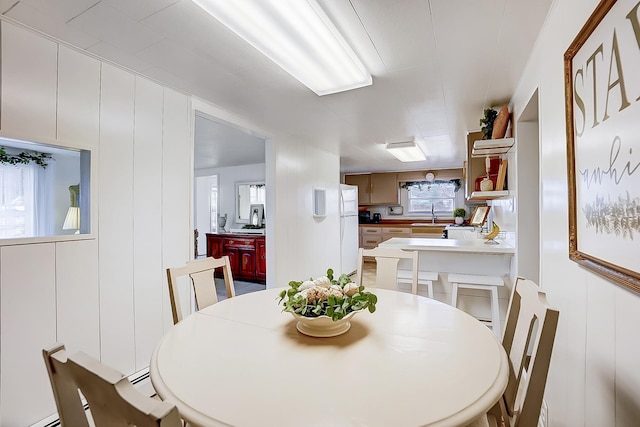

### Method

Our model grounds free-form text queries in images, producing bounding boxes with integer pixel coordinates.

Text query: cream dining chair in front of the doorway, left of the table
[167,255,236,324]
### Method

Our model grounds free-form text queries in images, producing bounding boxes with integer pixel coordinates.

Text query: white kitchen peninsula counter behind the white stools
[378,237,515,324]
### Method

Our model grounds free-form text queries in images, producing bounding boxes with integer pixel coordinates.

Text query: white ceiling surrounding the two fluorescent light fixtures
[0,0,552,172]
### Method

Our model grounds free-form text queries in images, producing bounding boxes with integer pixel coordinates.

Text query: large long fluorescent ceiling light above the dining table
[193,0,372,95]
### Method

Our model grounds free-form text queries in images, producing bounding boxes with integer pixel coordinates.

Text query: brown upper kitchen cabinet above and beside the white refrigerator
[344,173,399,205]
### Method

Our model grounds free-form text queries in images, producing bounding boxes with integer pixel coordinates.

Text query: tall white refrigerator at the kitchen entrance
[340,184,360,274]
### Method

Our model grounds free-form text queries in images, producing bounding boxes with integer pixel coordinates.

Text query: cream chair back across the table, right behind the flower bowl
[357,247,418,294]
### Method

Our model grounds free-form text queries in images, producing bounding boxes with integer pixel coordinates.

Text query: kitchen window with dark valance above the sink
[406,181,456,216]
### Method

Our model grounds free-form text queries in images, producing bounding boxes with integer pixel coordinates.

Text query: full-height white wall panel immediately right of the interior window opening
[98,64,135,375]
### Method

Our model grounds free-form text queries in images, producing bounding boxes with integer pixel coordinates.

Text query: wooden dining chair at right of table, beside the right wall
[472,277,559,427]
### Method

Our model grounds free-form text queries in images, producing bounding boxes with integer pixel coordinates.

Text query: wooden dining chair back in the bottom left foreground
[42,343,182,427]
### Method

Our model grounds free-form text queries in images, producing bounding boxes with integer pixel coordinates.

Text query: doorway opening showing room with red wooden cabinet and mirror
[193,111,266,294]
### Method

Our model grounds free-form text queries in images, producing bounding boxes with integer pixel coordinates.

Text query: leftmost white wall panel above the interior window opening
[0,22,58,139]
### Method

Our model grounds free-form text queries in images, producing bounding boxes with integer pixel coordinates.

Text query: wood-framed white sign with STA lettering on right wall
[564,0,640,292]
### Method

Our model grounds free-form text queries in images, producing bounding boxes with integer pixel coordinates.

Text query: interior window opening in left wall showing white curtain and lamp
[0,138,91,239]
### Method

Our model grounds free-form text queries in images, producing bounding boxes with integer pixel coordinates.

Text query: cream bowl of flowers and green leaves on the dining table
[279,269,378,337]
